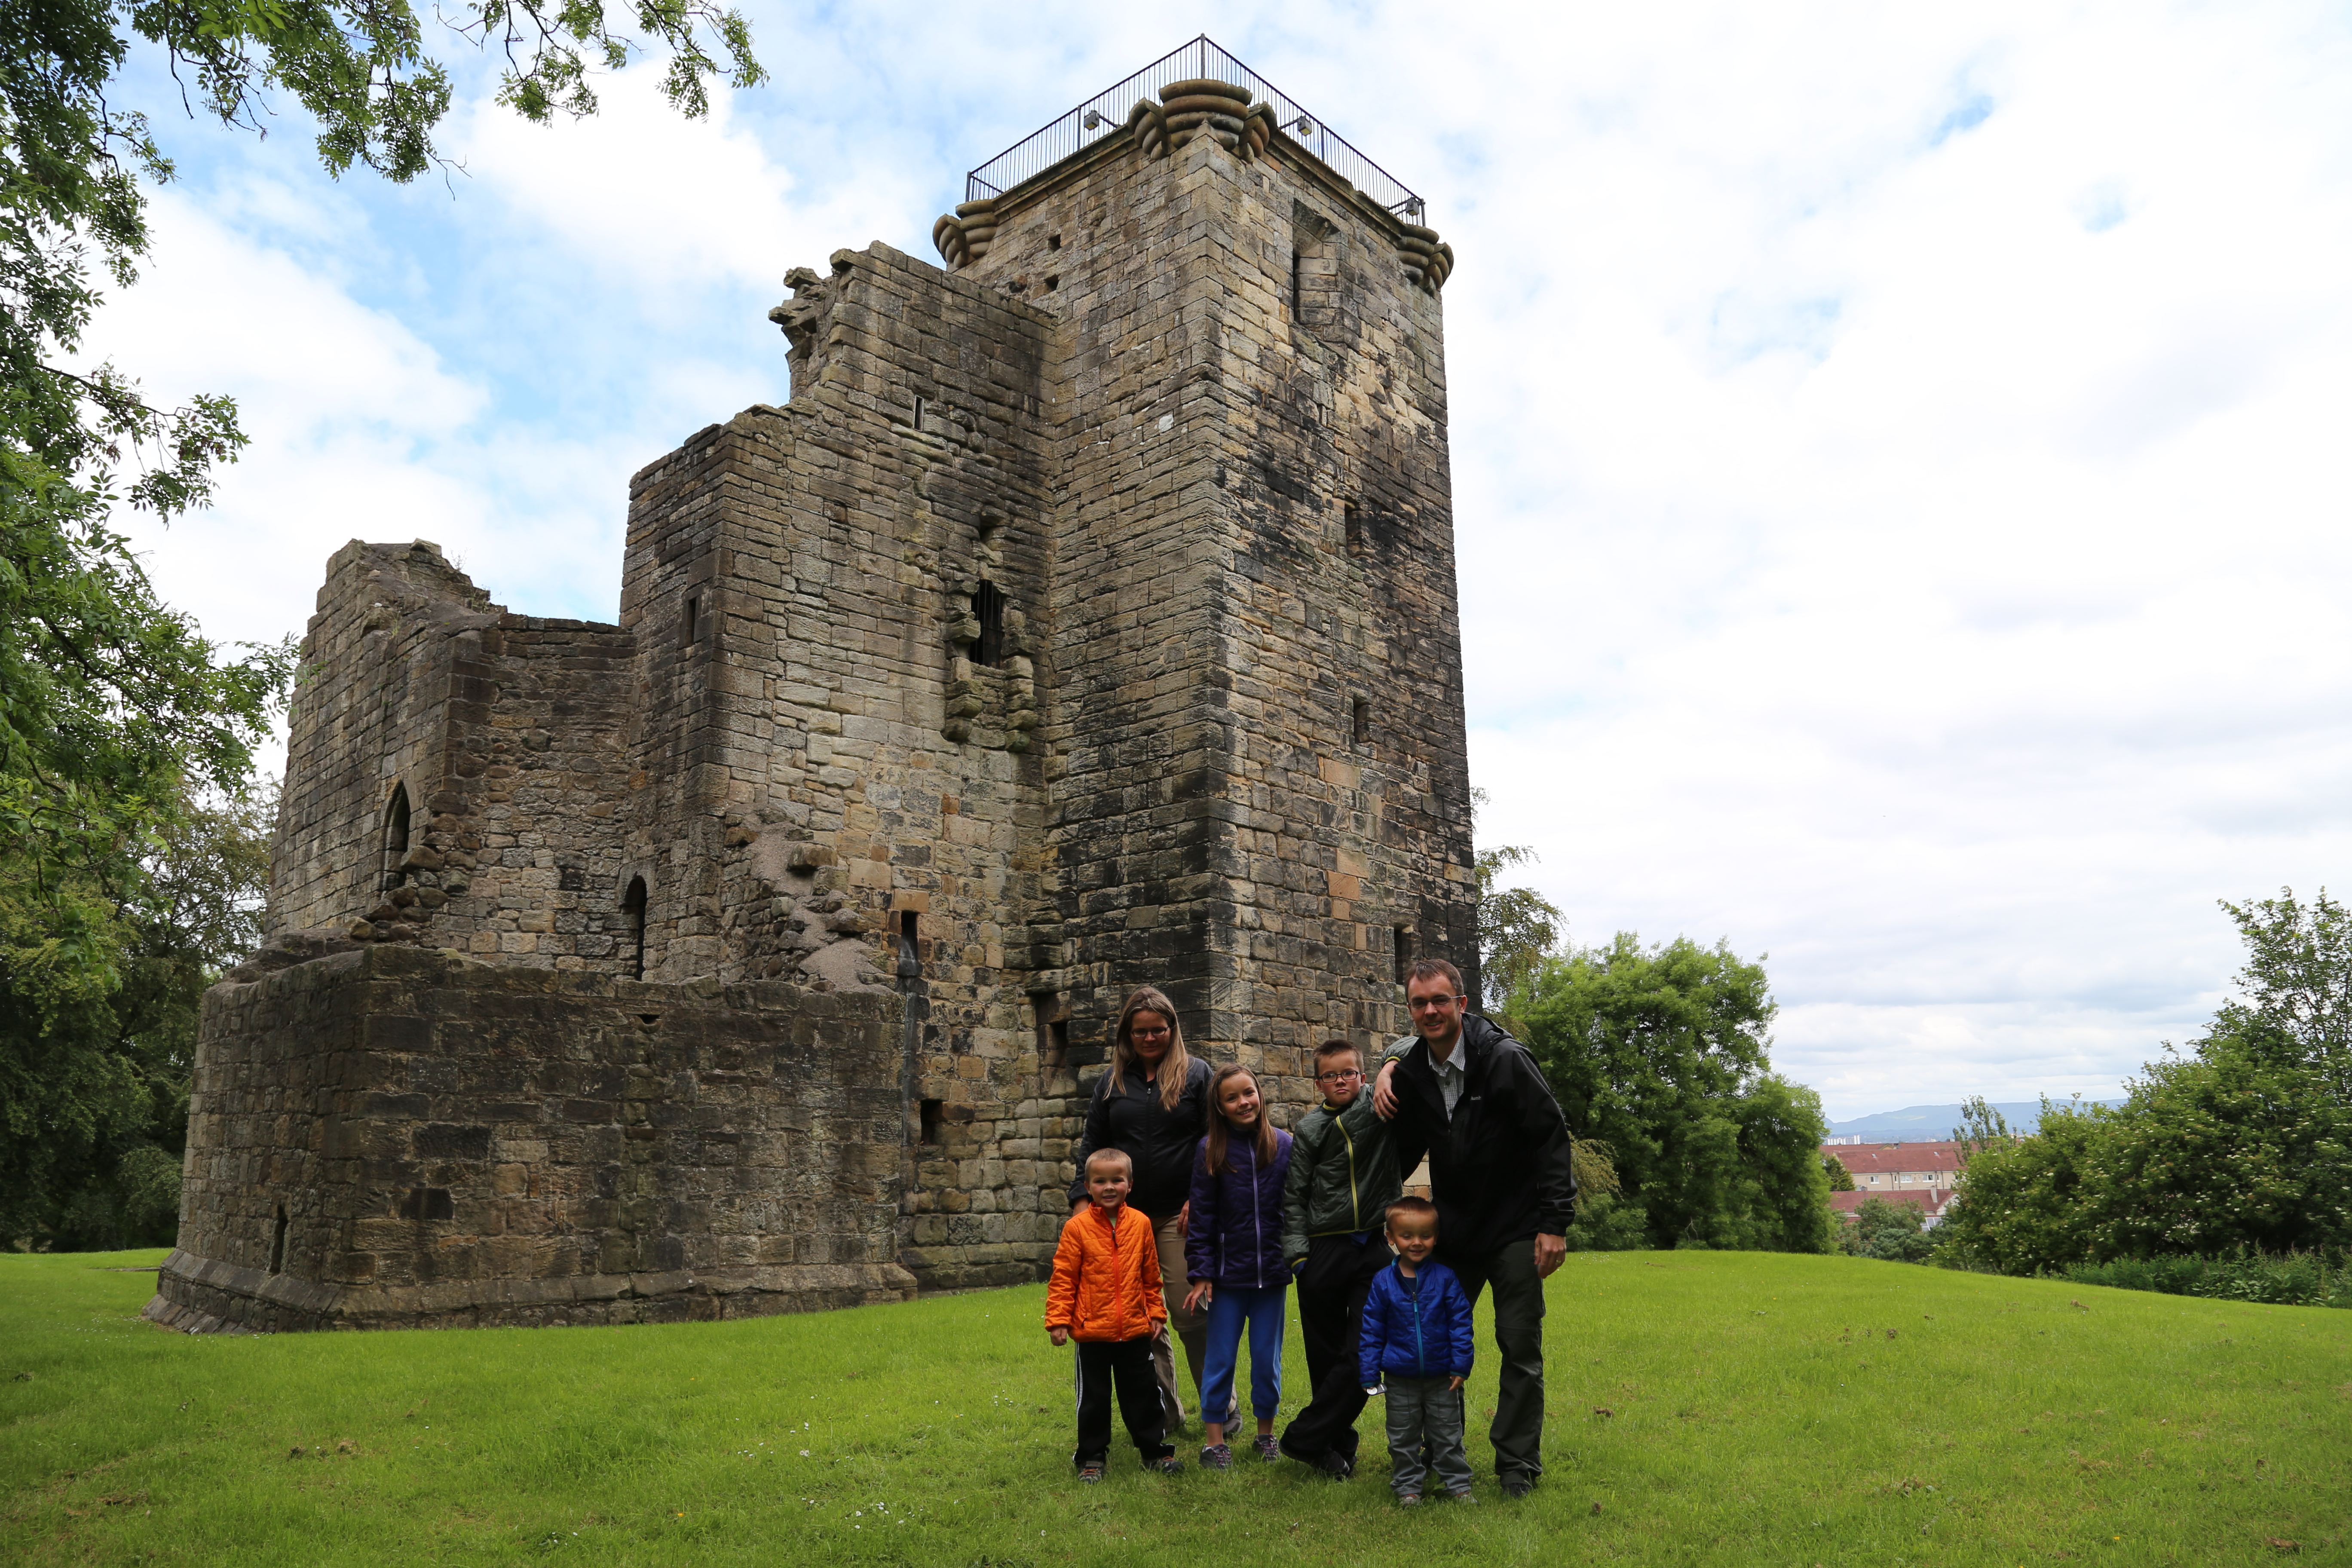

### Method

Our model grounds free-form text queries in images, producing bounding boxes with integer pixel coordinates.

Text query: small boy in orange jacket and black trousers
[1044,1149,1183,1481]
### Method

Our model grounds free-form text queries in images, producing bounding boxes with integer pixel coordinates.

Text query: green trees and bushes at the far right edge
[1938,891,2352,1274]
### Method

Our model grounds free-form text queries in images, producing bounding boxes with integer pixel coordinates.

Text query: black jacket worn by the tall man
[1390,1013,1576,1258]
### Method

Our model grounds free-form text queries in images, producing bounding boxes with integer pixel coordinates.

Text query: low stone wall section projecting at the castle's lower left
[150,945,915,1331]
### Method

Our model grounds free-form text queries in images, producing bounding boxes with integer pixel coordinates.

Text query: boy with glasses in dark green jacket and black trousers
[1282,1039,1404,1481]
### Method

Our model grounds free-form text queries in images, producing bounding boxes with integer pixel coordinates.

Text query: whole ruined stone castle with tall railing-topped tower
[150,40,1477,1328]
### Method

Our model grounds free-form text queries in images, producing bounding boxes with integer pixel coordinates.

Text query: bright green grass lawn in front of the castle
[0,1253,2352,1568]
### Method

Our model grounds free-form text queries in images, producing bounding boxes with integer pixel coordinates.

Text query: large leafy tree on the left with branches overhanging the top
[0,0,762,1239]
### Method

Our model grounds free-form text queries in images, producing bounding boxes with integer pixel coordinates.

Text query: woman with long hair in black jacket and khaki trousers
[1070,985,1209,1432]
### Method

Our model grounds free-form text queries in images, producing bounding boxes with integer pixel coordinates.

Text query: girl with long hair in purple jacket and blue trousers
[1185,1067,1291,1469]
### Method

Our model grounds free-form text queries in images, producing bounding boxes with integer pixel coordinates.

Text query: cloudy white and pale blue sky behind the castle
[99,0,2352,1117]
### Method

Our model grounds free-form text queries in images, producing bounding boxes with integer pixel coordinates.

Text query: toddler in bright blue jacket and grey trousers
[1360,1199,1472,1507]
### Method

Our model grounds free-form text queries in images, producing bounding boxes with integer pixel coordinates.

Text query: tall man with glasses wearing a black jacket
[1373,959,1576,1498]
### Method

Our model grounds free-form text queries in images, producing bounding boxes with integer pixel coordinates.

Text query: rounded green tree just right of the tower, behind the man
[1522,933,1834,1253]
